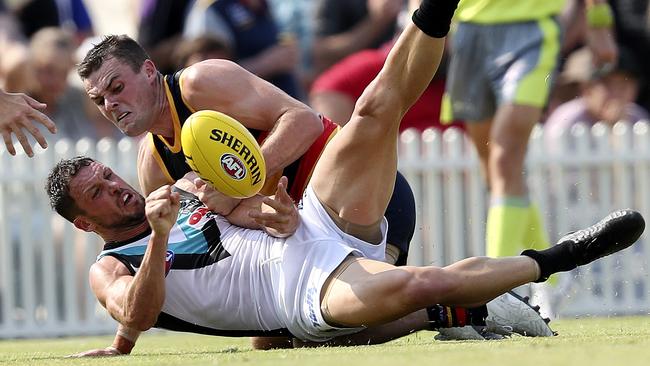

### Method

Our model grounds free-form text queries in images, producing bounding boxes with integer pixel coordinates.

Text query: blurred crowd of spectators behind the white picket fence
[0,0,650,145]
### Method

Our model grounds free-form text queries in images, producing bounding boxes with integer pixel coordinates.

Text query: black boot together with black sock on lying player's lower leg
[521,209,645,282]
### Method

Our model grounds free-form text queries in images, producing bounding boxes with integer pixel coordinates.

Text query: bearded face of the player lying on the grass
[70,161,146,230]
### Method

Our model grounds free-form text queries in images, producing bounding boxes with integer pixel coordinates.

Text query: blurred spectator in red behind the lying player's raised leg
[309,41,462,131]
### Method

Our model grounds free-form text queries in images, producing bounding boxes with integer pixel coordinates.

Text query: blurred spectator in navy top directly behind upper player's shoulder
[184,0,303,99]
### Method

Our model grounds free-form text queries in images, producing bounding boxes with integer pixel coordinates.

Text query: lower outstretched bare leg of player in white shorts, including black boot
[323,210,645,326]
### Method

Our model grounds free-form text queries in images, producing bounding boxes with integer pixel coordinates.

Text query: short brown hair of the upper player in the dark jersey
[77,34,150,79]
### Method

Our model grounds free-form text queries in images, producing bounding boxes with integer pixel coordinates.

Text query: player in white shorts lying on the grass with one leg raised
[47,0,645,355]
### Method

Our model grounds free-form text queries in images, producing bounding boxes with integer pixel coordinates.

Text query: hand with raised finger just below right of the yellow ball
[248,176,300,238]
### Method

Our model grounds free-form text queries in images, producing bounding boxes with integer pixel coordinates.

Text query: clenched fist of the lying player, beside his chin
[145,185,180,234]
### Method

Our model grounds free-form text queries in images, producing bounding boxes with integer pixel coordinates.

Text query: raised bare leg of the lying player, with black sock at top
[311,0,458,229]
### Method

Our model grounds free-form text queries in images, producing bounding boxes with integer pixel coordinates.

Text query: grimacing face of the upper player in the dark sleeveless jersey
[83,57,157,136]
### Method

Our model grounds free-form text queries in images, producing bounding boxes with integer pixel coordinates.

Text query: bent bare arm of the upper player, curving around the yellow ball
[181,60,323,176]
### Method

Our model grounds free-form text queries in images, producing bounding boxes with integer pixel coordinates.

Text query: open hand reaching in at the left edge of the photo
[0,90,56,157]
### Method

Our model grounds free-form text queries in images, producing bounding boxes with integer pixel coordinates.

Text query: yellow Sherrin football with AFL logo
[181,110,266,198]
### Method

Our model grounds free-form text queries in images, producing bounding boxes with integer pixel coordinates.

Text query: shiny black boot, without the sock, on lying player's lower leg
[557,209,645,266]
